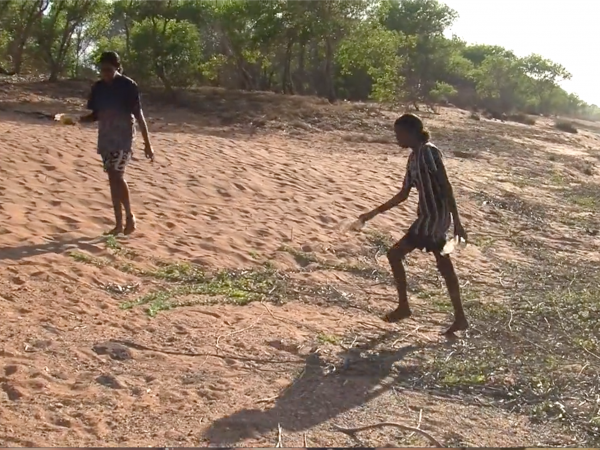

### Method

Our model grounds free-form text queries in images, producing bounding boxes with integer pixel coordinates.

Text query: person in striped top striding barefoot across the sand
[359,114,468,334]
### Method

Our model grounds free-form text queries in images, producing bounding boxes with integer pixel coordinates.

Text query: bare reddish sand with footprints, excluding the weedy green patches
[0,83,599,446]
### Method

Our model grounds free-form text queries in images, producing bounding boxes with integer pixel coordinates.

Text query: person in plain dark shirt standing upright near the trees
[80,52,154,234]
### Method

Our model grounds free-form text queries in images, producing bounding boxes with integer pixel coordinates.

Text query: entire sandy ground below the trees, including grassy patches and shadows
[0,83,600,447]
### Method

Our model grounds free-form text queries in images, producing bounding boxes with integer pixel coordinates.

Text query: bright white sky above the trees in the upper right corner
[442,0,600,105]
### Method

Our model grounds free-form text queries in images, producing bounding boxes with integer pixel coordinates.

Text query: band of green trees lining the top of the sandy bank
[0,0,600,119]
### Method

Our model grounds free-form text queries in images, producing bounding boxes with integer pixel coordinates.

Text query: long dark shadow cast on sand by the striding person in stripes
[204,333,446,446]
